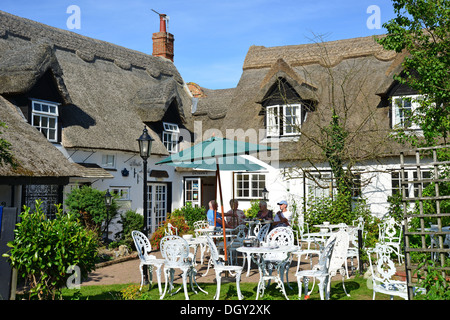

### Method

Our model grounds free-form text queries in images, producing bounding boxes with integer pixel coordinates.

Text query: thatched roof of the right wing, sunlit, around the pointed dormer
[195,37,403,161]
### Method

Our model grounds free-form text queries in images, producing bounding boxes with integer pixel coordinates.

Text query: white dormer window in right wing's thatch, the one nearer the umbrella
[266,104,302,137]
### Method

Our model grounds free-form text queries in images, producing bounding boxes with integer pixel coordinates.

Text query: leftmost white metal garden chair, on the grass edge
[131,230,164,295]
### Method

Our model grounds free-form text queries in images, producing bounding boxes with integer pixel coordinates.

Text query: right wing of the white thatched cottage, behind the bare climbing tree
[186,37,429,217]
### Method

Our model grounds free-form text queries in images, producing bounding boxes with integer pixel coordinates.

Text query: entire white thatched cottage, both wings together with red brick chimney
[0,12,428,238]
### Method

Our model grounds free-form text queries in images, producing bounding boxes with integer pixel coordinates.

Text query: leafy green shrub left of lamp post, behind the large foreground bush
[65,186,117,238]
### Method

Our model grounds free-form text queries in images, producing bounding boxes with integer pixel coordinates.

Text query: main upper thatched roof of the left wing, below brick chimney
[0,11,191,160]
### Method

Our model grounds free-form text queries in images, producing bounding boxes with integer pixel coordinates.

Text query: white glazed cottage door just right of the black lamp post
[148,183,167,234]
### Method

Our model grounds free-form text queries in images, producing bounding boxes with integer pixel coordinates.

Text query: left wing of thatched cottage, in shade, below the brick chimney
[0,12,196,235]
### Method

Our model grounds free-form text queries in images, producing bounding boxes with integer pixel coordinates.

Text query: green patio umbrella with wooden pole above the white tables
[156,137,273,260]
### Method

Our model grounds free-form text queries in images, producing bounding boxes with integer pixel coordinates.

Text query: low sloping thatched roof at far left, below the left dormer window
[0,96,84,178]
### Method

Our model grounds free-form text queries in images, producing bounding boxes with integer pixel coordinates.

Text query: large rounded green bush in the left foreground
[3,200,98,300]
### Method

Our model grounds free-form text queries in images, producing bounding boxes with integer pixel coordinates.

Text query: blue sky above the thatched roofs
[0,0,394,89]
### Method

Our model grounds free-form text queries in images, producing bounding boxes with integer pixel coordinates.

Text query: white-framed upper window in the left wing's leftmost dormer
[31,99,60,142]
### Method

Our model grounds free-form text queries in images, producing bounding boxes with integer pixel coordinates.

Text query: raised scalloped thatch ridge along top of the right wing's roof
[243,36,397,70]
